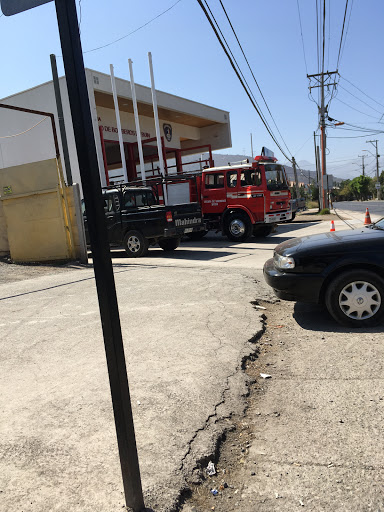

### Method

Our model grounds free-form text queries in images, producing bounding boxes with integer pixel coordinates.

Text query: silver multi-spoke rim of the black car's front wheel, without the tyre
[339,281,381,320]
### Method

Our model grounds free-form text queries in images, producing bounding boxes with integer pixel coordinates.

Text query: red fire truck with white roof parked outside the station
[158,148,292,242]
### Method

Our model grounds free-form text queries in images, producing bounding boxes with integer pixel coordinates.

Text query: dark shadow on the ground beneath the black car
[293,302,383,334]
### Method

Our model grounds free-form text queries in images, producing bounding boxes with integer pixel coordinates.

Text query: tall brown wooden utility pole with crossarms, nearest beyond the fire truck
[307,70,338,208]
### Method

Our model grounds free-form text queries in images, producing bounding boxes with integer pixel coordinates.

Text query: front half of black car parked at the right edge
[264,218,384,327]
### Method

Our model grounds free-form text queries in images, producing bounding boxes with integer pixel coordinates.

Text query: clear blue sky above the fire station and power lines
[0,0,384,179]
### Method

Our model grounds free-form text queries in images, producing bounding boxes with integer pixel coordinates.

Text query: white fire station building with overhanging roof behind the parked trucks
[0,69,231,186]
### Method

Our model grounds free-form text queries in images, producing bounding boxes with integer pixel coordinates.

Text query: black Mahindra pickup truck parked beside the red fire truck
[83,185,205,258]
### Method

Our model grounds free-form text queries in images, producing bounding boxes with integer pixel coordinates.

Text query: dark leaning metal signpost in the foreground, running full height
[55,0,144,512]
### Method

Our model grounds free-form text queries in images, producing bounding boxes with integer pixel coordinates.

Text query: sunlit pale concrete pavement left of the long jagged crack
[0,260,261,512]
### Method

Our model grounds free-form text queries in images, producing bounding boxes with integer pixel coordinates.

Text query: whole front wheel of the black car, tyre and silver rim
[325,270,384,327]
